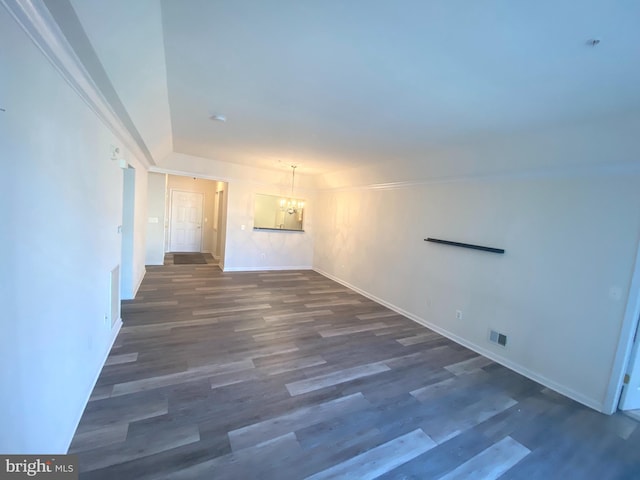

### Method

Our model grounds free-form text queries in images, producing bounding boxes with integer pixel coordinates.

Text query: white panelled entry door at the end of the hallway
[169,190,203,252]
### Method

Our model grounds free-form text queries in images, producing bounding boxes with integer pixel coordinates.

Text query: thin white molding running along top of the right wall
[317,162,640,192]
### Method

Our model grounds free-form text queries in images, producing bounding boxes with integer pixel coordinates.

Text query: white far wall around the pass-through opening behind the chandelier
[159,154,315,271]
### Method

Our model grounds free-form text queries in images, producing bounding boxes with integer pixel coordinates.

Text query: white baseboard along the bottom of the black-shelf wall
[313,268,604,412]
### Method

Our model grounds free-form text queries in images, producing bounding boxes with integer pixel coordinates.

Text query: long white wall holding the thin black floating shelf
[314,122,640,409]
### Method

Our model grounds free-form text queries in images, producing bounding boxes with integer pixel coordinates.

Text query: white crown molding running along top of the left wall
[0,0,152,168]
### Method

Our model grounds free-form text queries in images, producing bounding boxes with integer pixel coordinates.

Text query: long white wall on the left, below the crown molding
[0,8,146,454]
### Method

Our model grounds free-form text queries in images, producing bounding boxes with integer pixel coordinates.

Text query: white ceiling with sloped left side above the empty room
[62,0,640,173]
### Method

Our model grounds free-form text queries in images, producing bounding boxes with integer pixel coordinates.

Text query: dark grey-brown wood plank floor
[71,262,640,480]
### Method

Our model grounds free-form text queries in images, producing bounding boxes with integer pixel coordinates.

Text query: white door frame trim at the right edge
[603,236,640,414]
